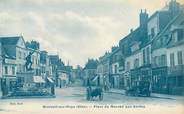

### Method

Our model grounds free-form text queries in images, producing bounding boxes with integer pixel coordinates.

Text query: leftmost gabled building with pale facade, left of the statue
[0,36,27,91]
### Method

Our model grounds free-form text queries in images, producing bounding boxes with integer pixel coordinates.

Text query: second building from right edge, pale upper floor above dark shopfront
[152,1,183,93]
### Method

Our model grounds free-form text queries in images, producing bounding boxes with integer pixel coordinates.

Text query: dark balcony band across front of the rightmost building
[168,65,184,76]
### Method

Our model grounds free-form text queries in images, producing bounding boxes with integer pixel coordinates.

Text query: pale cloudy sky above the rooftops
[0,0,184,66]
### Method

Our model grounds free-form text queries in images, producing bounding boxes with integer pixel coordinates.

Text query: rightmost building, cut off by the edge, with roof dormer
[166,12,184,95]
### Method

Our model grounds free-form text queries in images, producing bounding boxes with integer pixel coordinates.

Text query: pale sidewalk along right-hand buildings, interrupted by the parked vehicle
[106,89,184,100]
